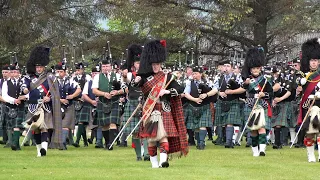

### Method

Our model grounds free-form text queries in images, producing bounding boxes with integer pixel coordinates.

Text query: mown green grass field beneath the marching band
[0,141,320,180]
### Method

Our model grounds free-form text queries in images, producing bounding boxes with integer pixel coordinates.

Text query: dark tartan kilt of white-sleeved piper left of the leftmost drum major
[3,106,25,130]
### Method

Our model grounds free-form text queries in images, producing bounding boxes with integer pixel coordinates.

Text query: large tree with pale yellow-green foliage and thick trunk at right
[101,0,319,64]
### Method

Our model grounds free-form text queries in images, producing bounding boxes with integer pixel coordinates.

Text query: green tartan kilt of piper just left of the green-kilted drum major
[214,99,243,126]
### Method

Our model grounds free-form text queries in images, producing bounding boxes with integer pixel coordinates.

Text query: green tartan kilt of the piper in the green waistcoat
[93,101,120,126]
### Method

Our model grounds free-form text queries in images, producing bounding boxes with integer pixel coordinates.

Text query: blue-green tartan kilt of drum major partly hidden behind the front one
[122,99,141,134]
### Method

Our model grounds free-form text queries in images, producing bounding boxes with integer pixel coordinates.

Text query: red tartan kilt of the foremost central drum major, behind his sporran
[139,103,179,138]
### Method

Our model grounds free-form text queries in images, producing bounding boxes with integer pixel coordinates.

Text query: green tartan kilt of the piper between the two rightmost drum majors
[271,102,290,127]
